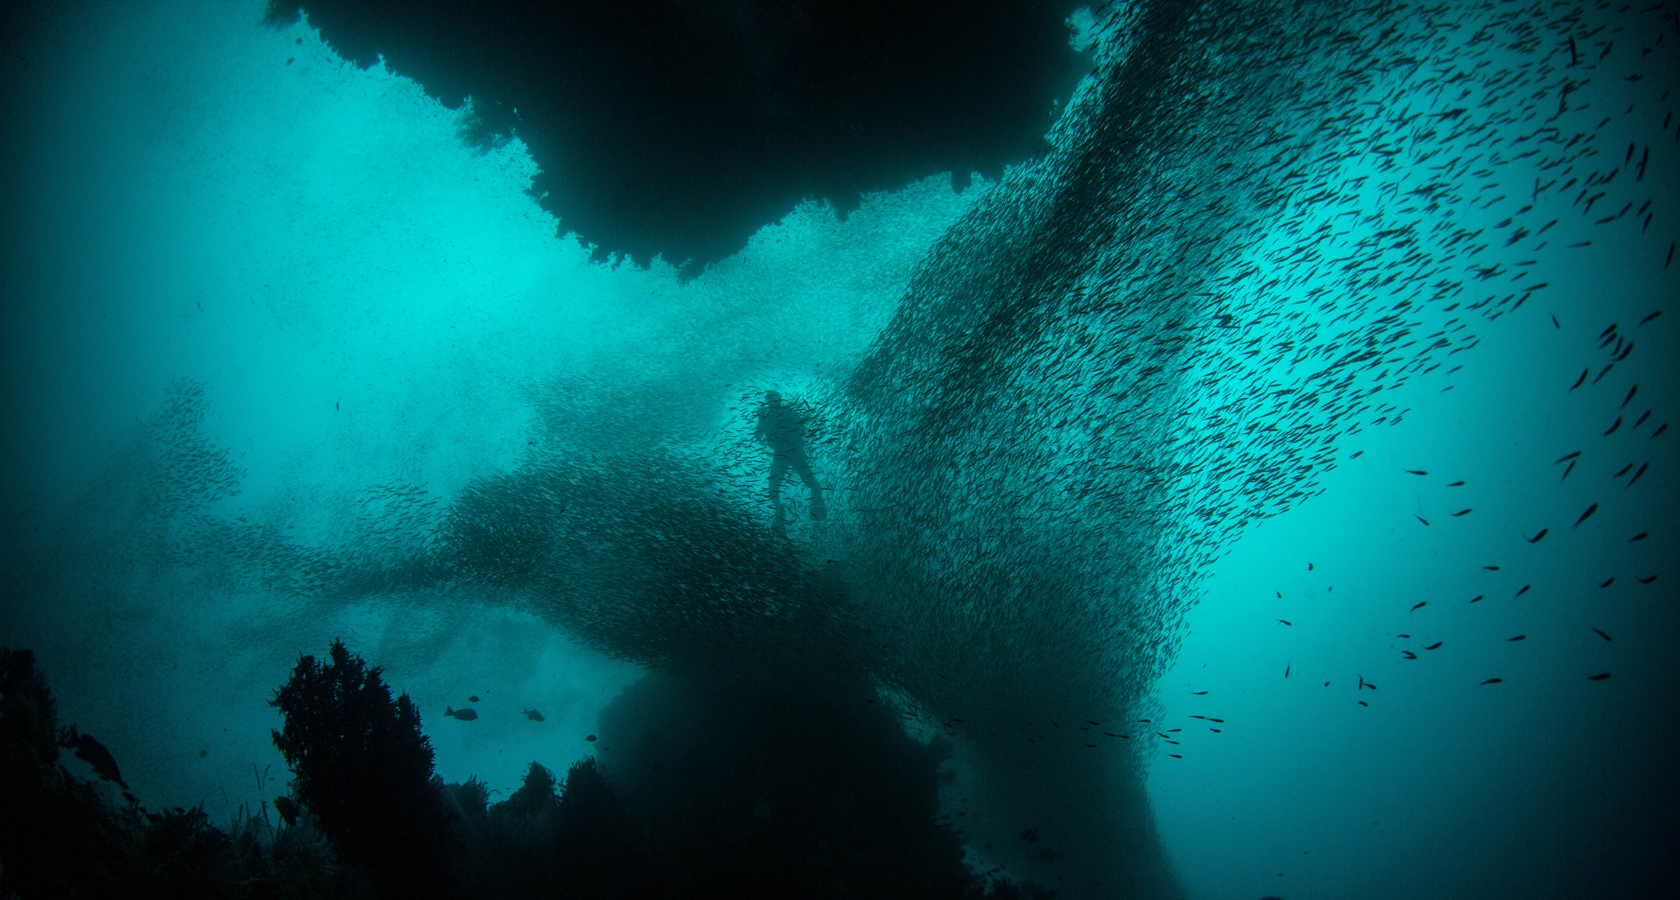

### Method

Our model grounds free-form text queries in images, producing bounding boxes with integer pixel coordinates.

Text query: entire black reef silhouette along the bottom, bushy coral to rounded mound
[0,641,1050,900]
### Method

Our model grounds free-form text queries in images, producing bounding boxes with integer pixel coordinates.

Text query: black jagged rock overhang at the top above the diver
[269,0,1089,275]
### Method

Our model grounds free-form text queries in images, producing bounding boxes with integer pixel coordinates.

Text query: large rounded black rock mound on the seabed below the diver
[591,668,971,900]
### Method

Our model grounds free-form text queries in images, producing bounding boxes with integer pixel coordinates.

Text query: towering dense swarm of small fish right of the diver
[813,2,1680,752]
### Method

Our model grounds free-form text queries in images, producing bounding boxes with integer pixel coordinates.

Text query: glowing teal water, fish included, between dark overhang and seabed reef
[0,0,1680,900]
